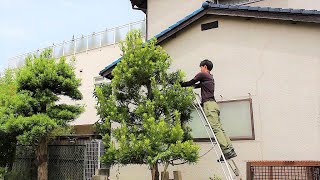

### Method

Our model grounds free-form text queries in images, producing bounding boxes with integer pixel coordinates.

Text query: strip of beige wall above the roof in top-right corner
[250,0,320,10]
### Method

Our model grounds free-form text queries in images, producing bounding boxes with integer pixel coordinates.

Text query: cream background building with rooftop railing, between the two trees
[9,20,146,125]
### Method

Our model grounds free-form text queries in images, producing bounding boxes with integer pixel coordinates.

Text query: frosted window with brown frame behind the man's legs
[190,99,255,141]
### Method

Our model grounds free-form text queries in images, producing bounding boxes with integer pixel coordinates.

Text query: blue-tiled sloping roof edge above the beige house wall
[99,1,320,78]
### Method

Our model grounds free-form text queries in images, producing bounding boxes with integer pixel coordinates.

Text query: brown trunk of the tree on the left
[36,138,48,180]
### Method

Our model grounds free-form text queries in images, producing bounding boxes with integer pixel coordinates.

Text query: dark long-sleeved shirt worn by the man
[181,72,215,103]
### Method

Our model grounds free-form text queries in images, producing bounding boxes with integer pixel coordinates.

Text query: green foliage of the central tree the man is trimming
[95,31,199,172]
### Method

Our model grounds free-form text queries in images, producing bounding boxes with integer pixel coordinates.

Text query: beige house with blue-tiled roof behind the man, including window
[100,0,320,180]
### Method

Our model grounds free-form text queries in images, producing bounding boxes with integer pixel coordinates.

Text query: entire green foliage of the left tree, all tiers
[2,50,83,146]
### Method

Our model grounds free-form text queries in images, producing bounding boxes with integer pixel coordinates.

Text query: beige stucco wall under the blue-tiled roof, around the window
[112,17,320,180]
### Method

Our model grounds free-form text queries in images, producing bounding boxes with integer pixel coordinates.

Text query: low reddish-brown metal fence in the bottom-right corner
[247,161,320,180]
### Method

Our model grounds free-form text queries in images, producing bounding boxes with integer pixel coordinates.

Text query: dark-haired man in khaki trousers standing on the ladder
[180,59,237,162]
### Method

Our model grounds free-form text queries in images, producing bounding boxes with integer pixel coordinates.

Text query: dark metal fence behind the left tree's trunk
[10,139,104,180]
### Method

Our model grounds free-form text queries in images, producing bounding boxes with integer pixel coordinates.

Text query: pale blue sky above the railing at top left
[0,0,145,70]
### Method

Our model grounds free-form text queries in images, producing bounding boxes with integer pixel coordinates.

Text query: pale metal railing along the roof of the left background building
[8,20,146,68]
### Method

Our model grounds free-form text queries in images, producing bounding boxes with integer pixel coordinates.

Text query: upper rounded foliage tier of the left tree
[17,50,82,101]
